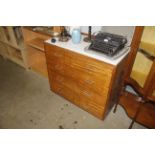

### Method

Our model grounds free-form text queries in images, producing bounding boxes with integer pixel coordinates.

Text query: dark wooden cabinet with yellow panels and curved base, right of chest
[114,26,155,128]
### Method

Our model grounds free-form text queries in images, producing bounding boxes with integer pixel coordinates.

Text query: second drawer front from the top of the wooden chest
[48,59,112,95]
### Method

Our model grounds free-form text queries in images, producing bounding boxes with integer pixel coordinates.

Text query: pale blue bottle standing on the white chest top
[72,28,81,44]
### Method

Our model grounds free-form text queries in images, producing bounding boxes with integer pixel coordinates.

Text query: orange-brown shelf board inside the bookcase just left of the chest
[27,38,44,51]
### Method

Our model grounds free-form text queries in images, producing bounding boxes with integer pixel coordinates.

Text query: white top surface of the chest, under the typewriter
[45,36,130,65]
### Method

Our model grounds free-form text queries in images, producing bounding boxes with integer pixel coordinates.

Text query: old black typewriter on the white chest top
[89,32,127,56]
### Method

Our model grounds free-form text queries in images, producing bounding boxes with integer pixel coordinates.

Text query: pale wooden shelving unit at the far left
[0,26,26,68]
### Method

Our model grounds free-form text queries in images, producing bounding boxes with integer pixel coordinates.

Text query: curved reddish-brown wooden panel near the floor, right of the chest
[119,92,155,128]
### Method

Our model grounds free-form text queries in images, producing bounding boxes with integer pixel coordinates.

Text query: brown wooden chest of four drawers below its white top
[45,43,125,119]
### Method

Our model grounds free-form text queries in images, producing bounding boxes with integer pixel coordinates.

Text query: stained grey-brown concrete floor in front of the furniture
[0,56,145,129]
